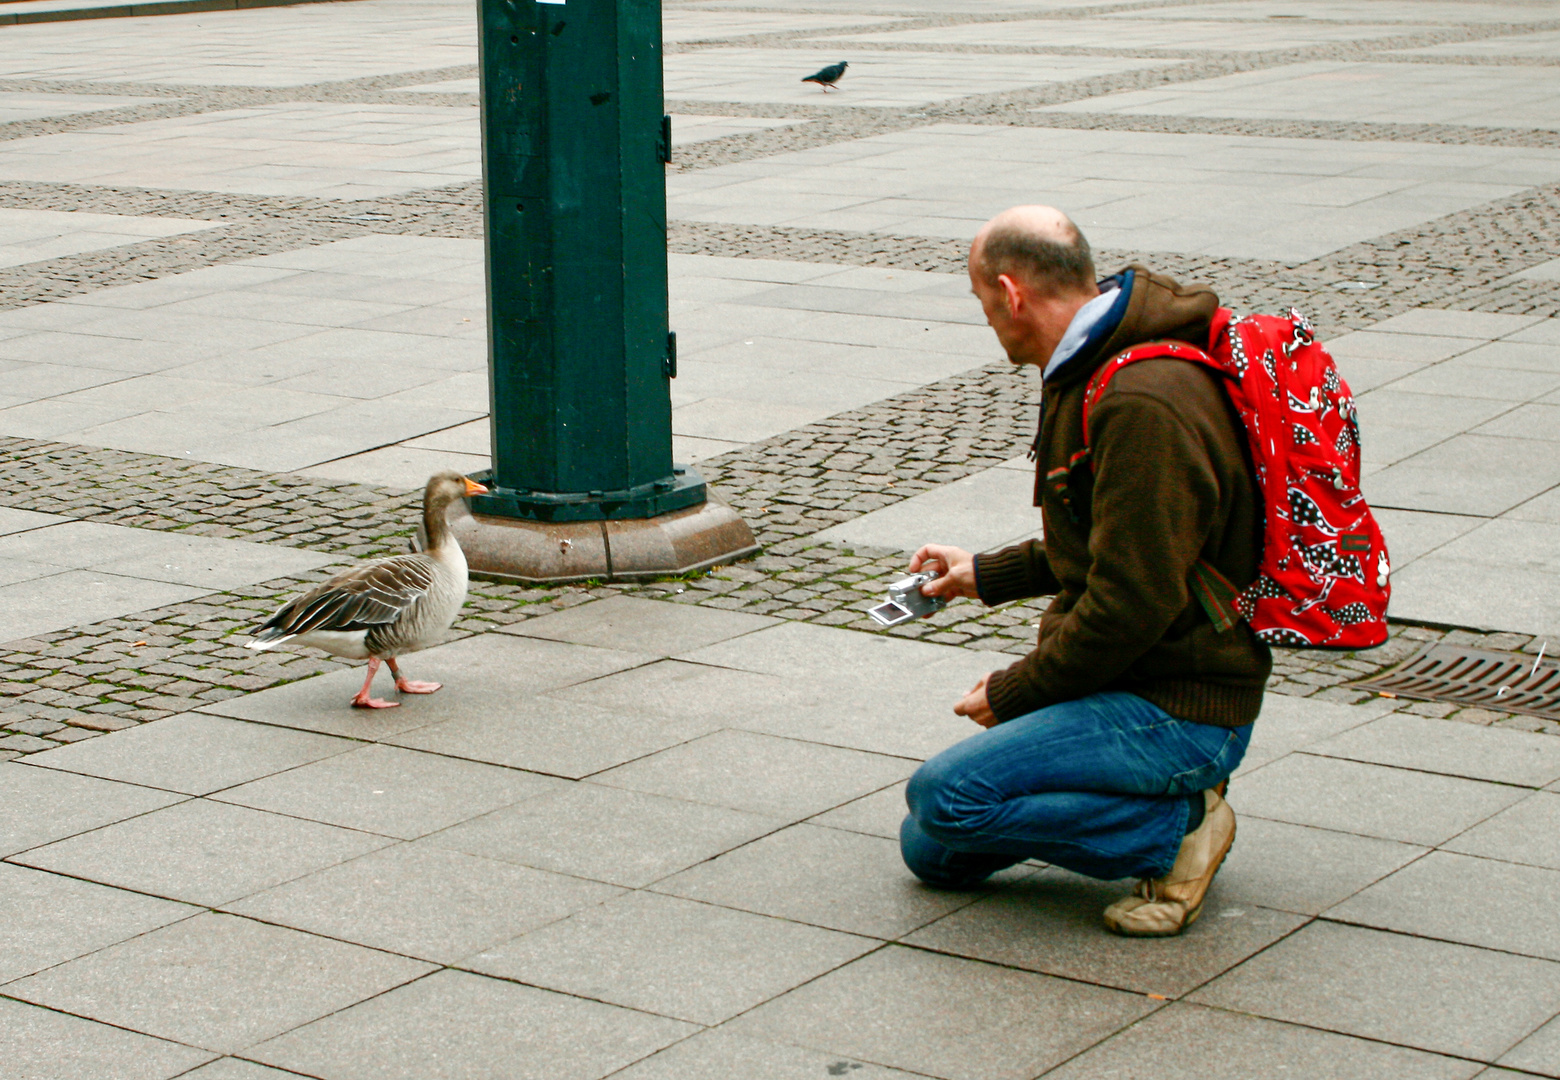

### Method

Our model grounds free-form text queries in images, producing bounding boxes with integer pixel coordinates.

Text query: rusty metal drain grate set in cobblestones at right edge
[1349,645,1560,721]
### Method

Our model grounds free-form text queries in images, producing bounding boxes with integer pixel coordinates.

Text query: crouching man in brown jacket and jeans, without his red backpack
[900,206,1273,936]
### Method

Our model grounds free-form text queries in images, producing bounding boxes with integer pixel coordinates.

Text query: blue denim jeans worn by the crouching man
[900,693,1251,888]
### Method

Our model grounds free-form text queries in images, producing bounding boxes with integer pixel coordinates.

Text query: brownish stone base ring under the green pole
[430,493,758,585]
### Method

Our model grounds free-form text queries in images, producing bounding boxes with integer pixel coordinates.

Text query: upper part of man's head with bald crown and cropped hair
[970,206,1095,295]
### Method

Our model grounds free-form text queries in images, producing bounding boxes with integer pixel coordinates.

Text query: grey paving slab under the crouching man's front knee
[654,824,1004,938]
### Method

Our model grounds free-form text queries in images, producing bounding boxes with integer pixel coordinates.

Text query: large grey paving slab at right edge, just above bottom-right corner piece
[1192,922,1560,1061]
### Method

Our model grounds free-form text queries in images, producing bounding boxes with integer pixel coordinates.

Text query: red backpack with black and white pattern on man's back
[1083,307,1392,649]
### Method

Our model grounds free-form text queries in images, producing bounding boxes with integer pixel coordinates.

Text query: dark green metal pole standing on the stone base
[471,0,705,521]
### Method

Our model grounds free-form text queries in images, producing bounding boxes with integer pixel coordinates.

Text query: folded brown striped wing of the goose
[254,554,434,641]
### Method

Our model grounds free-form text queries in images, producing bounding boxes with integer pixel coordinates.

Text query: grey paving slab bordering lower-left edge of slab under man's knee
[462,893,878,1024]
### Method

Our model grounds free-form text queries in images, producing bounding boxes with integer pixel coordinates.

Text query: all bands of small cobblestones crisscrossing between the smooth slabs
[0,3,1560,754]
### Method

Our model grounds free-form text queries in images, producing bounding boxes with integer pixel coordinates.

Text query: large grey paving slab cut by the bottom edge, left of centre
[246,971,699,1080]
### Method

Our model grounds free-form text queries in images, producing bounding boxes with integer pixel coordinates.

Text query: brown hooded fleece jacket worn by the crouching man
[975,267,1273,727]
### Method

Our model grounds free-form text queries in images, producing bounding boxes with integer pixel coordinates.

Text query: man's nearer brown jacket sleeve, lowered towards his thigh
[983,379,1220,719]
